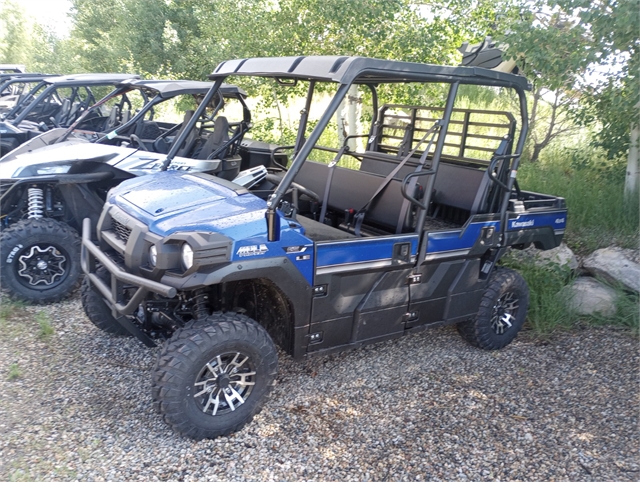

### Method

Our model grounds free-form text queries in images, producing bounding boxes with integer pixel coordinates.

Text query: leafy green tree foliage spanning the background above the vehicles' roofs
[0,0,640,165]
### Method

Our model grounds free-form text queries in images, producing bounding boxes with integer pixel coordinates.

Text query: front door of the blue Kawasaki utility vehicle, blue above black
[309,235,418,351]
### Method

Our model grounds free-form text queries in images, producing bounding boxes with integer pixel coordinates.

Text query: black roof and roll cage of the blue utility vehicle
[170,56,531,243]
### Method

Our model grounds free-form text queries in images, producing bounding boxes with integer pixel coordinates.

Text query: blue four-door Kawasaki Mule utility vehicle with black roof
[82,57,567,439]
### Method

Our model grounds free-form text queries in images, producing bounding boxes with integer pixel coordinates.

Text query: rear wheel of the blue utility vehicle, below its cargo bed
[457,268,529,350]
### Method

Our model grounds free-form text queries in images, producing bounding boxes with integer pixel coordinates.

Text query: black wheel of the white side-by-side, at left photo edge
[0,218,81,304]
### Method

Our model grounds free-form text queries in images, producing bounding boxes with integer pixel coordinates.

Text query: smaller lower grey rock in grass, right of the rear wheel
[561,276,618,318]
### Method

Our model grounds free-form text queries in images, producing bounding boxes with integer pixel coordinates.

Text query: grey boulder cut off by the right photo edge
[582,248,640,292]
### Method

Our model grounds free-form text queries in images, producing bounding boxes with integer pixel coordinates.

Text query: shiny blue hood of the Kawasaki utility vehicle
[108,171,267,239]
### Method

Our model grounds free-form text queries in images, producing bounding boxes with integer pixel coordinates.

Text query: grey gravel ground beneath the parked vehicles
[0,299,640,481]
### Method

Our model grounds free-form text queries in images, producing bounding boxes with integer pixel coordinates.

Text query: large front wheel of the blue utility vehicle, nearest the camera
[152,313,278,440]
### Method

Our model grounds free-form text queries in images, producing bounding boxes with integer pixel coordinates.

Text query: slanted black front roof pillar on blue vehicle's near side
[266,84,351,241]
